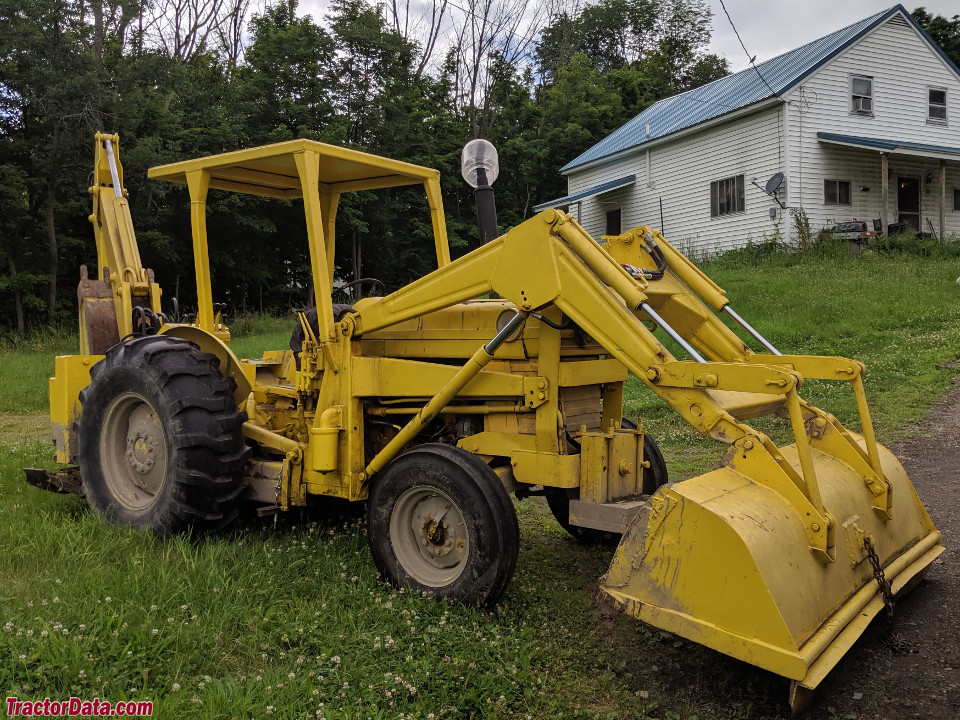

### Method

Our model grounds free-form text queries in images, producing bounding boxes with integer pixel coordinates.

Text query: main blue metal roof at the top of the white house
[560,5,960,172]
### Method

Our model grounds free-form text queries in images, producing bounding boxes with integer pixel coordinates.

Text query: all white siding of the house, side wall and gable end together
[568,6,960,250]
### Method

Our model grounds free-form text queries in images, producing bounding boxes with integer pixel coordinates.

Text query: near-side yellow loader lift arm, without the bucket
[352,210,887,562]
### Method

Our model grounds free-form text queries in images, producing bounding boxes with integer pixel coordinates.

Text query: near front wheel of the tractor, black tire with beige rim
[367,443,520,606]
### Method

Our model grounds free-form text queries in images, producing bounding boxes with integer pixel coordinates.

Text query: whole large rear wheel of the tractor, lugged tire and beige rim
[76,335,250,537]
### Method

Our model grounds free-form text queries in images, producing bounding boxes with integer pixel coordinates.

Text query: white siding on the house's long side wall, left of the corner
[568,107,785,256]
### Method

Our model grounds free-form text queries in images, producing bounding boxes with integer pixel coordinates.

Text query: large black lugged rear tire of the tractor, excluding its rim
[74,335,250,537]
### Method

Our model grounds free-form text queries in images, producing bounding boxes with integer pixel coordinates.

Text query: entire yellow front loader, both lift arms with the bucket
[351,211,943,708]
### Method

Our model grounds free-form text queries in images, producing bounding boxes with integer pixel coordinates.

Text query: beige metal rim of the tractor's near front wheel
[390,486,470,588]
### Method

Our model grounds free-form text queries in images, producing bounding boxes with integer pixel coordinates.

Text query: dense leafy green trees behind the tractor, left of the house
[0,0,726,332]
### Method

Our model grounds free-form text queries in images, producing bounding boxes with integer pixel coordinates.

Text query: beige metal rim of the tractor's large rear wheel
[100,392,167,510]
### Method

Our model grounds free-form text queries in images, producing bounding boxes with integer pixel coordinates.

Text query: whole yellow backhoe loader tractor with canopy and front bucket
[27,135,943,706]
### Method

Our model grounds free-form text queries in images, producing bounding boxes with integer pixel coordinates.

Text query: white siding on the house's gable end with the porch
[785,15,960,235]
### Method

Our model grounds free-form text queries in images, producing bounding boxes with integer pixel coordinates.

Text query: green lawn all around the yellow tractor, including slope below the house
[0,250,960,720]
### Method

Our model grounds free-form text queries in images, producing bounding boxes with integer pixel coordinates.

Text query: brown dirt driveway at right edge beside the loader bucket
[807,378,960,720]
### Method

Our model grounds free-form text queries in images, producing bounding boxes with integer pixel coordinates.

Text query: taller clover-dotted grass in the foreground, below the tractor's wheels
[0,442,724,719]
